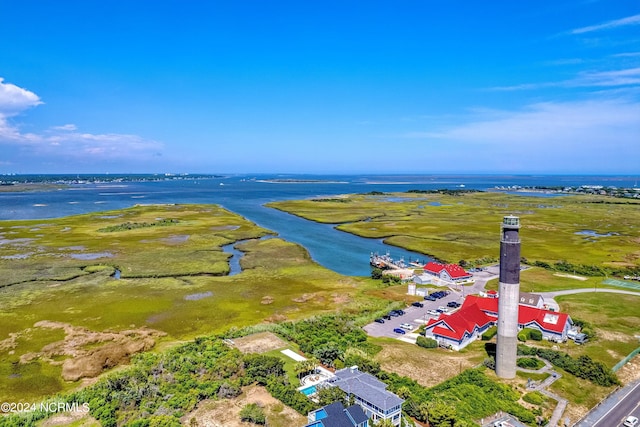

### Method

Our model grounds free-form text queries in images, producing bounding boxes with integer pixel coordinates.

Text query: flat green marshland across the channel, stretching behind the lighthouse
[269,193,640,267]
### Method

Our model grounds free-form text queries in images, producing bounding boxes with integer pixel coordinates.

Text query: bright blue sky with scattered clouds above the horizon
[0,0,640,175]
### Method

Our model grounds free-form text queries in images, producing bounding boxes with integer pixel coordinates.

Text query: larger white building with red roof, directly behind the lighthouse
[425,295,573,350]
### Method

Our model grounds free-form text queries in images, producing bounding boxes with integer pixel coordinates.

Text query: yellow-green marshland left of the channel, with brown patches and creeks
[0,205,384,400]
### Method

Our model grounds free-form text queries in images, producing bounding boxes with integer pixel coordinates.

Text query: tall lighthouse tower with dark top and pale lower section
[496,215,520,378]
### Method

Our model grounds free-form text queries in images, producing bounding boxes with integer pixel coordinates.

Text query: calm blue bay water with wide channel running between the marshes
[0,175,637,276]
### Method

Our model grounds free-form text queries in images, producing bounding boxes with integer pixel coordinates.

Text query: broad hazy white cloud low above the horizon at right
[403,100,640,173]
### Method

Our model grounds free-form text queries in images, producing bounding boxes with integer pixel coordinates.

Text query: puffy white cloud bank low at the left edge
[0,78,163,169]
